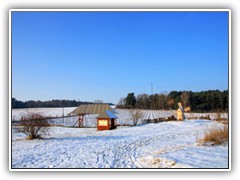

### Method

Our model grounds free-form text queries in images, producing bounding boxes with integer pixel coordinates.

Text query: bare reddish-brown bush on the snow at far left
[18,113,50,140]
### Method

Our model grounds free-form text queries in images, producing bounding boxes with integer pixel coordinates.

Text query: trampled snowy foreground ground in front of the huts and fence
[12,120,228,168]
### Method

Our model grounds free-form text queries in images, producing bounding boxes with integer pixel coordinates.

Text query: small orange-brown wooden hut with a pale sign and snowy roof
[97,110,117,130]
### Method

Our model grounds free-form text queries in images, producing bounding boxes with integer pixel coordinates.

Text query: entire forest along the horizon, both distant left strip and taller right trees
[12,90,228,112]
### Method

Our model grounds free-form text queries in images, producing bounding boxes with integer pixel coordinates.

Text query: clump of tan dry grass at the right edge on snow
[198,125,228,145]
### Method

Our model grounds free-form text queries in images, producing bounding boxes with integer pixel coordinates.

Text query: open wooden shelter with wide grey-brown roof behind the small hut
[69,104,117,127]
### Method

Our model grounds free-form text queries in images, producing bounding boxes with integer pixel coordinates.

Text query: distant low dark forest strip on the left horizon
[12,98,112,109]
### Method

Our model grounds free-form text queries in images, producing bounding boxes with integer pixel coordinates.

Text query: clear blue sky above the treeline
[11,12,228,103]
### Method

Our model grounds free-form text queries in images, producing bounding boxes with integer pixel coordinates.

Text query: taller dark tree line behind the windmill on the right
[117,90,228,112]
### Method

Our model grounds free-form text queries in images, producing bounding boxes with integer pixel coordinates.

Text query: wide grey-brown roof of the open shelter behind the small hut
[69,104,117,114]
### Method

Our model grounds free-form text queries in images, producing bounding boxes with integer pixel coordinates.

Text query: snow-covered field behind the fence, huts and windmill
[12,107,228,127]
